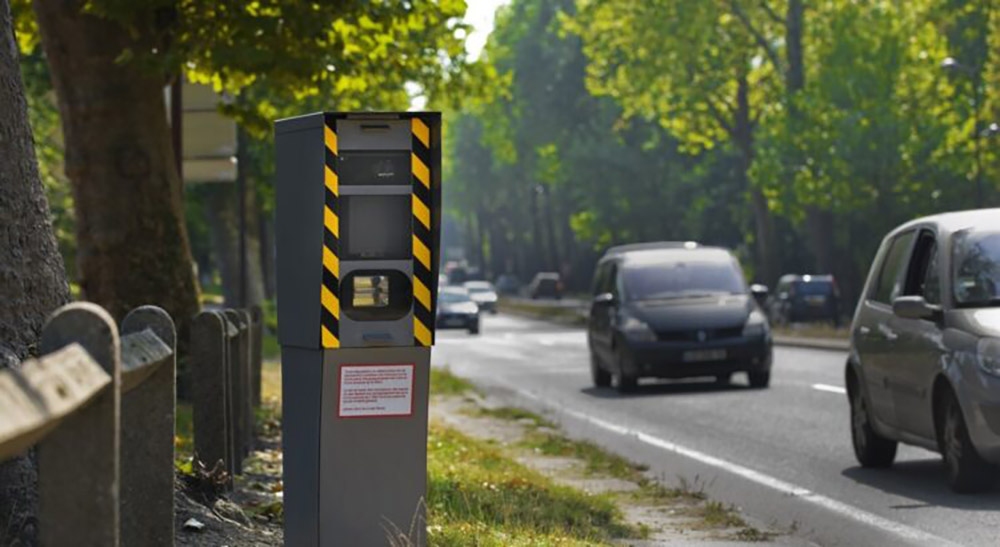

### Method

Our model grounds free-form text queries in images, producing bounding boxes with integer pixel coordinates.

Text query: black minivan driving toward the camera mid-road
[587,243,771,391]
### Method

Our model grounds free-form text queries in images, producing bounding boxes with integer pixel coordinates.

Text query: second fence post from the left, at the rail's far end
[121,306,177,547]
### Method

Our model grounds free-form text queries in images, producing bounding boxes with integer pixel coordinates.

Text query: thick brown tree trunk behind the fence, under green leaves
[34,0,199,332]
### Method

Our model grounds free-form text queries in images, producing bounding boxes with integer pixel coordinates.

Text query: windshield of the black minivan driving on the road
[623,261,746,300]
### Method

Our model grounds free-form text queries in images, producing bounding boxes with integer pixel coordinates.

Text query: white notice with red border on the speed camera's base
[339,364,414,418]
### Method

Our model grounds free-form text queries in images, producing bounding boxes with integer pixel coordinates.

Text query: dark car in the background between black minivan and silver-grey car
[767,274,840,326]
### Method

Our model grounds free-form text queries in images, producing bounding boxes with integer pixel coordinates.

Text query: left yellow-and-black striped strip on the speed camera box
[320,115,340,349]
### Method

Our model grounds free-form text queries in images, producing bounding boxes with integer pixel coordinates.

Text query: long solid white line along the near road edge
[501,380,958,546]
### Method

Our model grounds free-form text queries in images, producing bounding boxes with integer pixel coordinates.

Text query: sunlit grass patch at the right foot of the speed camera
[426,426,644,546]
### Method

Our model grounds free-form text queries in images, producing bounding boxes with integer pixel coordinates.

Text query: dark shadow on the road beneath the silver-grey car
[842,457,1000,511]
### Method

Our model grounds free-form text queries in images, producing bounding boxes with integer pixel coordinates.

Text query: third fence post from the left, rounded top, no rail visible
[190,311,234,484]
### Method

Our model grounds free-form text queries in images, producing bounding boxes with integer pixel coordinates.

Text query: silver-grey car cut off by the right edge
[846,209,1000,492]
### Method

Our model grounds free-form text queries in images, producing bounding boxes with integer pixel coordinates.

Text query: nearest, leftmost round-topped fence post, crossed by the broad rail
[38,302,121,547]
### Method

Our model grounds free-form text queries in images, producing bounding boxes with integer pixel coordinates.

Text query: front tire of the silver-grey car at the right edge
[939,393,997,494]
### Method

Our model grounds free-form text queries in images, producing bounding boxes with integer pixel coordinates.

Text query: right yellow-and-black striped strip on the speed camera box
[410,118,436,346]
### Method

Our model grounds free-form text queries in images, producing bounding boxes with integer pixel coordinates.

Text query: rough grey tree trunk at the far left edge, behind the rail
[0,0,69,545]
